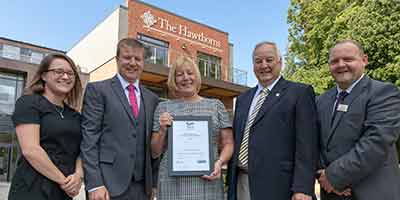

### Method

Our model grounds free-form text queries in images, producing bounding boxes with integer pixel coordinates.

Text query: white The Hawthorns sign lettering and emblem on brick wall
[141,11,221,48]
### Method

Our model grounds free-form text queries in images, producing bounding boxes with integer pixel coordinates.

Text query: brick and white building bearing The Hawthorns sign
[67,0,248,111]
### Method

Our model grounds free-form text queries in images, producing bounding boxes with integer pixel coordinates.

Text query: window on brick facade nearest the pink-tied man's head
[138,35,169,65]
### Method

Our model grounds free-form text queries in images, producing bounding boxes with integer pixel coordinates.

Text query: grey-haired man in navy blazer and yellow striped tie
[228,42,319,200]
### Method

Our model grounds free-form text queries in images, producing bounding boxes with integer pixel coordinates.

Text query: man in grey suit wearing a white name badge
[317,40,400,200]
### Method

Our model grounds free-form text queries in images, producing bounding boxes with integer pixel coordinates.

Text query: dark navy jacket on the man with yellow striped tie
[228,78,319,200]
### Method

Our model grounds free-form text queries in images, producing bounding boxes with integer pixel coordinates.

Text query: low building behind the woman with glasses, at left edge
[0,37,89,183]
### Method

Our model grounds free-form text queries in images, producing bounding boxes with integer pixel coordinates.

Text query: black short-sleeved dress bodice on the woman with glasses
[12,94,82,176]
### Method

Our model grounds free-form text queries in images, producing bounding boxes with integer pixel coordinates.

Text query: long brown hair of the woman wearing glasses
[25,53,82,108]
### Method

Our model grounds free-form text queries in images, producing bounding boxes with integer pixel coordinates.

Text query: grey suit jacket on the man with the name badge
[317,76,400,200]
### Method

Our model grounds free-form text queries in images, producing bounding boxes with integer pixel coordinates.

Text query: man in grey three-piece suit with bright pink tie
[81,38,159,200]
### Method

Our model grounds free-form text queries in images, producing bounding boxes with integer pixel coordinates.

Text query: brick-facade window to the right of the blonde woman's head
[197,52,221,79]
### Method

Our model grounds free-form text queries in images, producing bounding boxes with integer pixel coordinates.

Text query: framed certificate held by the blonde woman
[168,116,214,176]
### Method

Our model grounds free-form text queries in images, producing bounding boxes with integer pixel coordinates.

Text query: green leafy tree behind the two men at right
[285,0,400,93]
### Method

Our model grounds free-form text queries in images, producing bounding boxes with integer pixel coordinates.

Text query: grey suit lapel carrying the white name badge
[327,75,369,144]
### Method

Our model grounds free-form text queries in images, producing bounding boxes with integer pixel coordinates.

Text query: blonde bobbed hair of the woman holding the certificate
[167,56,201,97]
